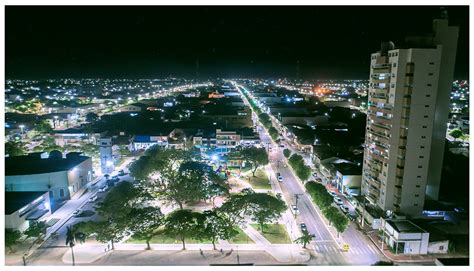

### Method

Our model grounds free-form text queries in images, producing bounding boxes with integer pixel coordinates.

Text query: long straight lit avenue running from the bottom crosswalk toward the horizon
[238,82,385,265]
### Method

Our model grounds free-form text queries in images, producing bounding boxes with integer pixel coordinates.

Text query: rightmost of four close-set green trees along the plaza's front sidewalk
[199,211,238,250]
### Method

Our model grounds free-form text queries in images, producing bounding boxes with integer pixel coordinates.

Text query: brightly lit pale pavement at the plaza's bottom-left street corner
[62,245,111,265]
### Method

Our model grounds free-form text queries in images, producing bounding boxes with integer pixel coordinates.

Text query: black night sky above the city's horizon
[5,6,469,79]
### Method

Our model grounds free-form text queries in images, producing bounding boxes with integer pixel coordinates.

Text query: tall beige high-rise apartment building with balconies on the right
[362,19,459,216]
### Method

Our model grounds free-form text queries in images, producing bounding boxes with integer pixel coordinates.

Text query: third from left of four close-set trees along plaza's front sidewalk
[165,210,204,250]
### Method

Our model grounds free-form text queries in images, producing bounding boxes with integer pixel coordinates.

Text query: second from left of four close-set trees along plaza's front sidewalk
[129,207,163,249]
